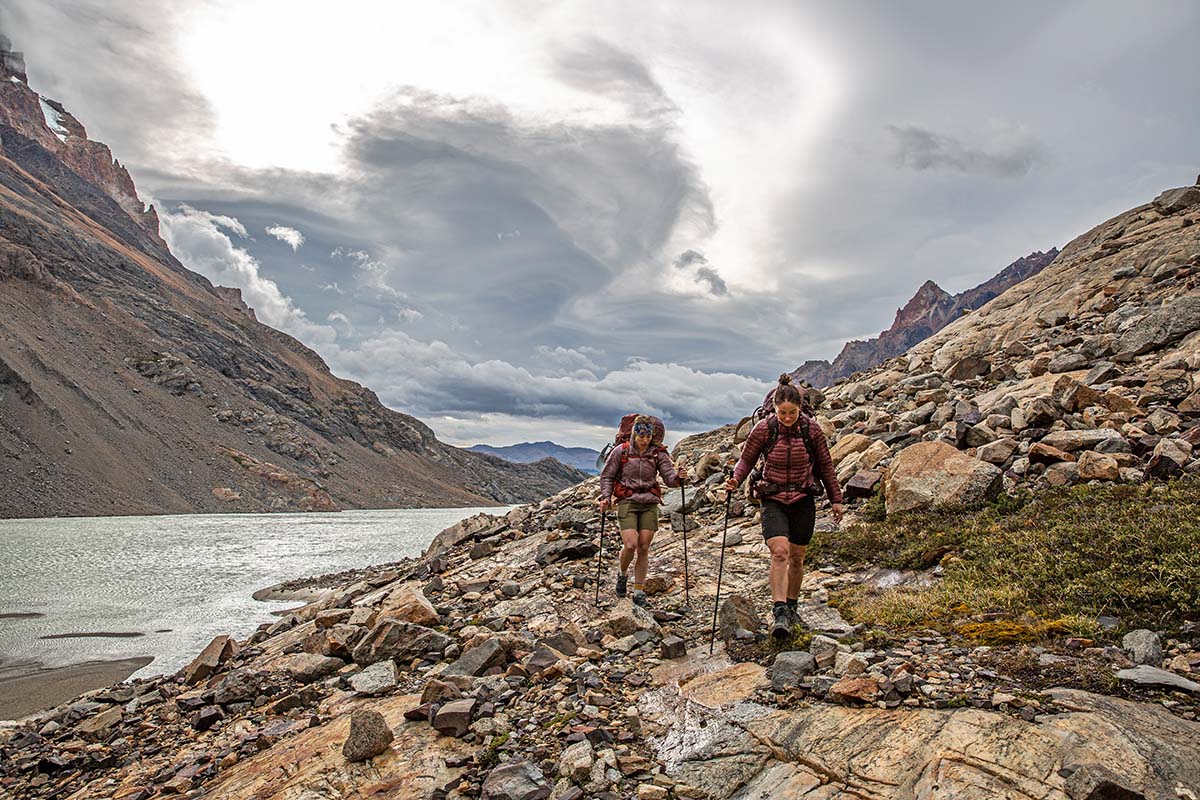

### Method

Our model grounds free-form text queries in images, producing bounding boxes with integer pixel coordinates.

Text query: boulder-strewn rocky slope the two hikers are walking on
[0,186,1200,800]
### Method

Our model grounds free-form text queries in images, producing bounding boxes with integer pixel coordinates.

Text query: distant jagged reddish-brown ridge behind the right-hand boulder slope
[792,247,1058,386]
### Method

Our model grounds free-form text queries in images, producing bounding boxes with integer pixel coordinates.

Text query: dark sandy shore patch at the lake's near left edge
[0,656,154,720]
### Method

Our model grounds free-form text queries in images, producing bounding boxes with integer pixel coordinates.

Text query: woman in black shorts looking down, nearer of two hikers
[725,373,842,639]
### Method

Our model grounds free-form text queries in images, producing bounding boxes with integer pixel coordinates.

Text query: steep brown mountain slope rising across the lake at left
[0,42,583,517]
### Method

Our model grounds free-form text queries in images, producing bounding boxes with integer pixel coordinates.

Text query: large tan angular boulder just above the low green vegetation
[883,441,1003,513]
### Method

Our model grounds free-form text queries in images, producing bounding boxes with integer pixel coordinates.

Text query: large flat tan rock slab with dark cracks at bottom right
[638,684,1200,800]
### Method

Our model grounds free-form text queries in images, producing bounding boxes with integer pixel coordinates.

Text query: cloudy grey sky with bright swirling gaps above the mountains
[0,0,1200,446]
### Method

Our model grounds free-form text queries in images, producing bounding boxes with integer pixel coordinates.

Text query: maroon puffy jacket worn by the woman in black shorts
[733,416,841,504]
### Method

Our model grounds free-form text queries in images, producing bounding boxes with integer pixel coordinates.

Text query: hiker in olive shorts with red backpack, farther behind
[596,415,688,606]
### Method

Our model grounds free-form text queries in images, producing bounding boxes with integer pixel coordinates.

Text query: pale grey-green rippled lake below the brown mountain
[0,507,496,678]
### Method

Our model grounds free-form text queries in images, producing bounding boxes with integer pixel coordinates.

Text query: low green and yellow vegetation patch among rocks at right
[812,477,1200,644]
